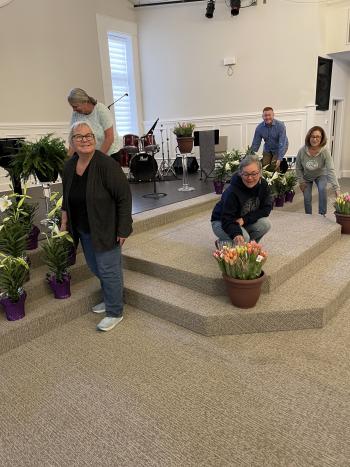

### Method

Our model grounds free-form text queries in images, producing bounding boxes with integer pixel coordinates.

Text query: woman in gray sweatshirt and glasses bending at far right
[296,126,340,216]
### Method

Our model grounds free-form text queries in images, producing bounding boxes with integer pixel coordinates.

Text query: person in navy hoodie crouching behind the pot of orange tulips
[211,154,272,244]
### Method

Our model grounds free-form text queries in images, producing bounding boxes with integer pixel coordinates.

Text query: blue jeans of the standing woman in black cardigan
[79,232,123,318]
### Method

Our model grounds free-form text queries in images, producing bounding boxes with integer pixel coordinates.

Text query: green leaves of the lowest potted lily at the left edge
[0,253,29,302]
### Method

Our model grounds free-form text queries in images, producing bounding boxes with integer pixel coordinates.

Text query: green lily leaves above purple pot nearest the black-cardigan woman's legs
[42,232,73,282]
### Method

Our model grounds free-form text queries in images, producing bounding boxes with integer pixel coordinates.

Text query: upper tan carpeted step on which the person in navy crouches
[123,211,340,295]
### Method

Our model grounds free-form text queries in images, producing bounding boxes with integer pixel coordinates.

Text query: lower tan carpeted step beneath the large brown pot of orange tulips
[125,236,350,336]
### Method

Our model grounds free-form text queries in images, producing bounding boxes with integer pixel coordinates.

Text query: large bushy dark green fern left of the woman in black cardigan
[11,133,67,183]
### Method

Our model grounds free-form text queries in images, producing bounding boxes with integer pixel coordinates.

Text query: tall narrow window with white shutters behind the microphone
[108,32,138,136]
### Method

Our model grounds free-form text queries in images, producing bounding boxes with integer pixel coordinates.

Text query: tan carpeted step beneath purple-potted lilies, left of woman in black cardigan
[0,278,101,354]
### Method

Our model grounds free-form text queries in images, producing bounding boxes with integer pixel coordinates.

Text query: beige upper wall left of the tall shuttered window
[0,0,135,123]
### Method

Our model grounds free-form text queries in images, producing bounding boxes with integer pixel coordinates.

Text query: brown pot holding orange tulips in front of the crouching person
[222,271,265,308]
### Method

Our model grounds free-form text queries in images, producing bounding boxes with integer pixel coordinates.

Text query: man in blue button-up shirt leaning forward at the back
[251,107,288,170]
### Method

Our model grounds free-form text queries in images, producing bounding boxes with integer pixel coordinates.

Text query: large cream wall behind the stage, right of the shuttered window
[138,0,322,120]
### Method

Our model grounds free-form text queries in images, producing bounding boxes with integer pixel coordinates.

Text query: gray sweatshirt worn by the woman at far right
[296,146,340,190]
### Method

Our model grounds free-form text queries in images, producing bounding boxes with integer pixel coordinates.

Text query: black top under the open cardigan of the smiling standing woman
[69,164,90,233]
